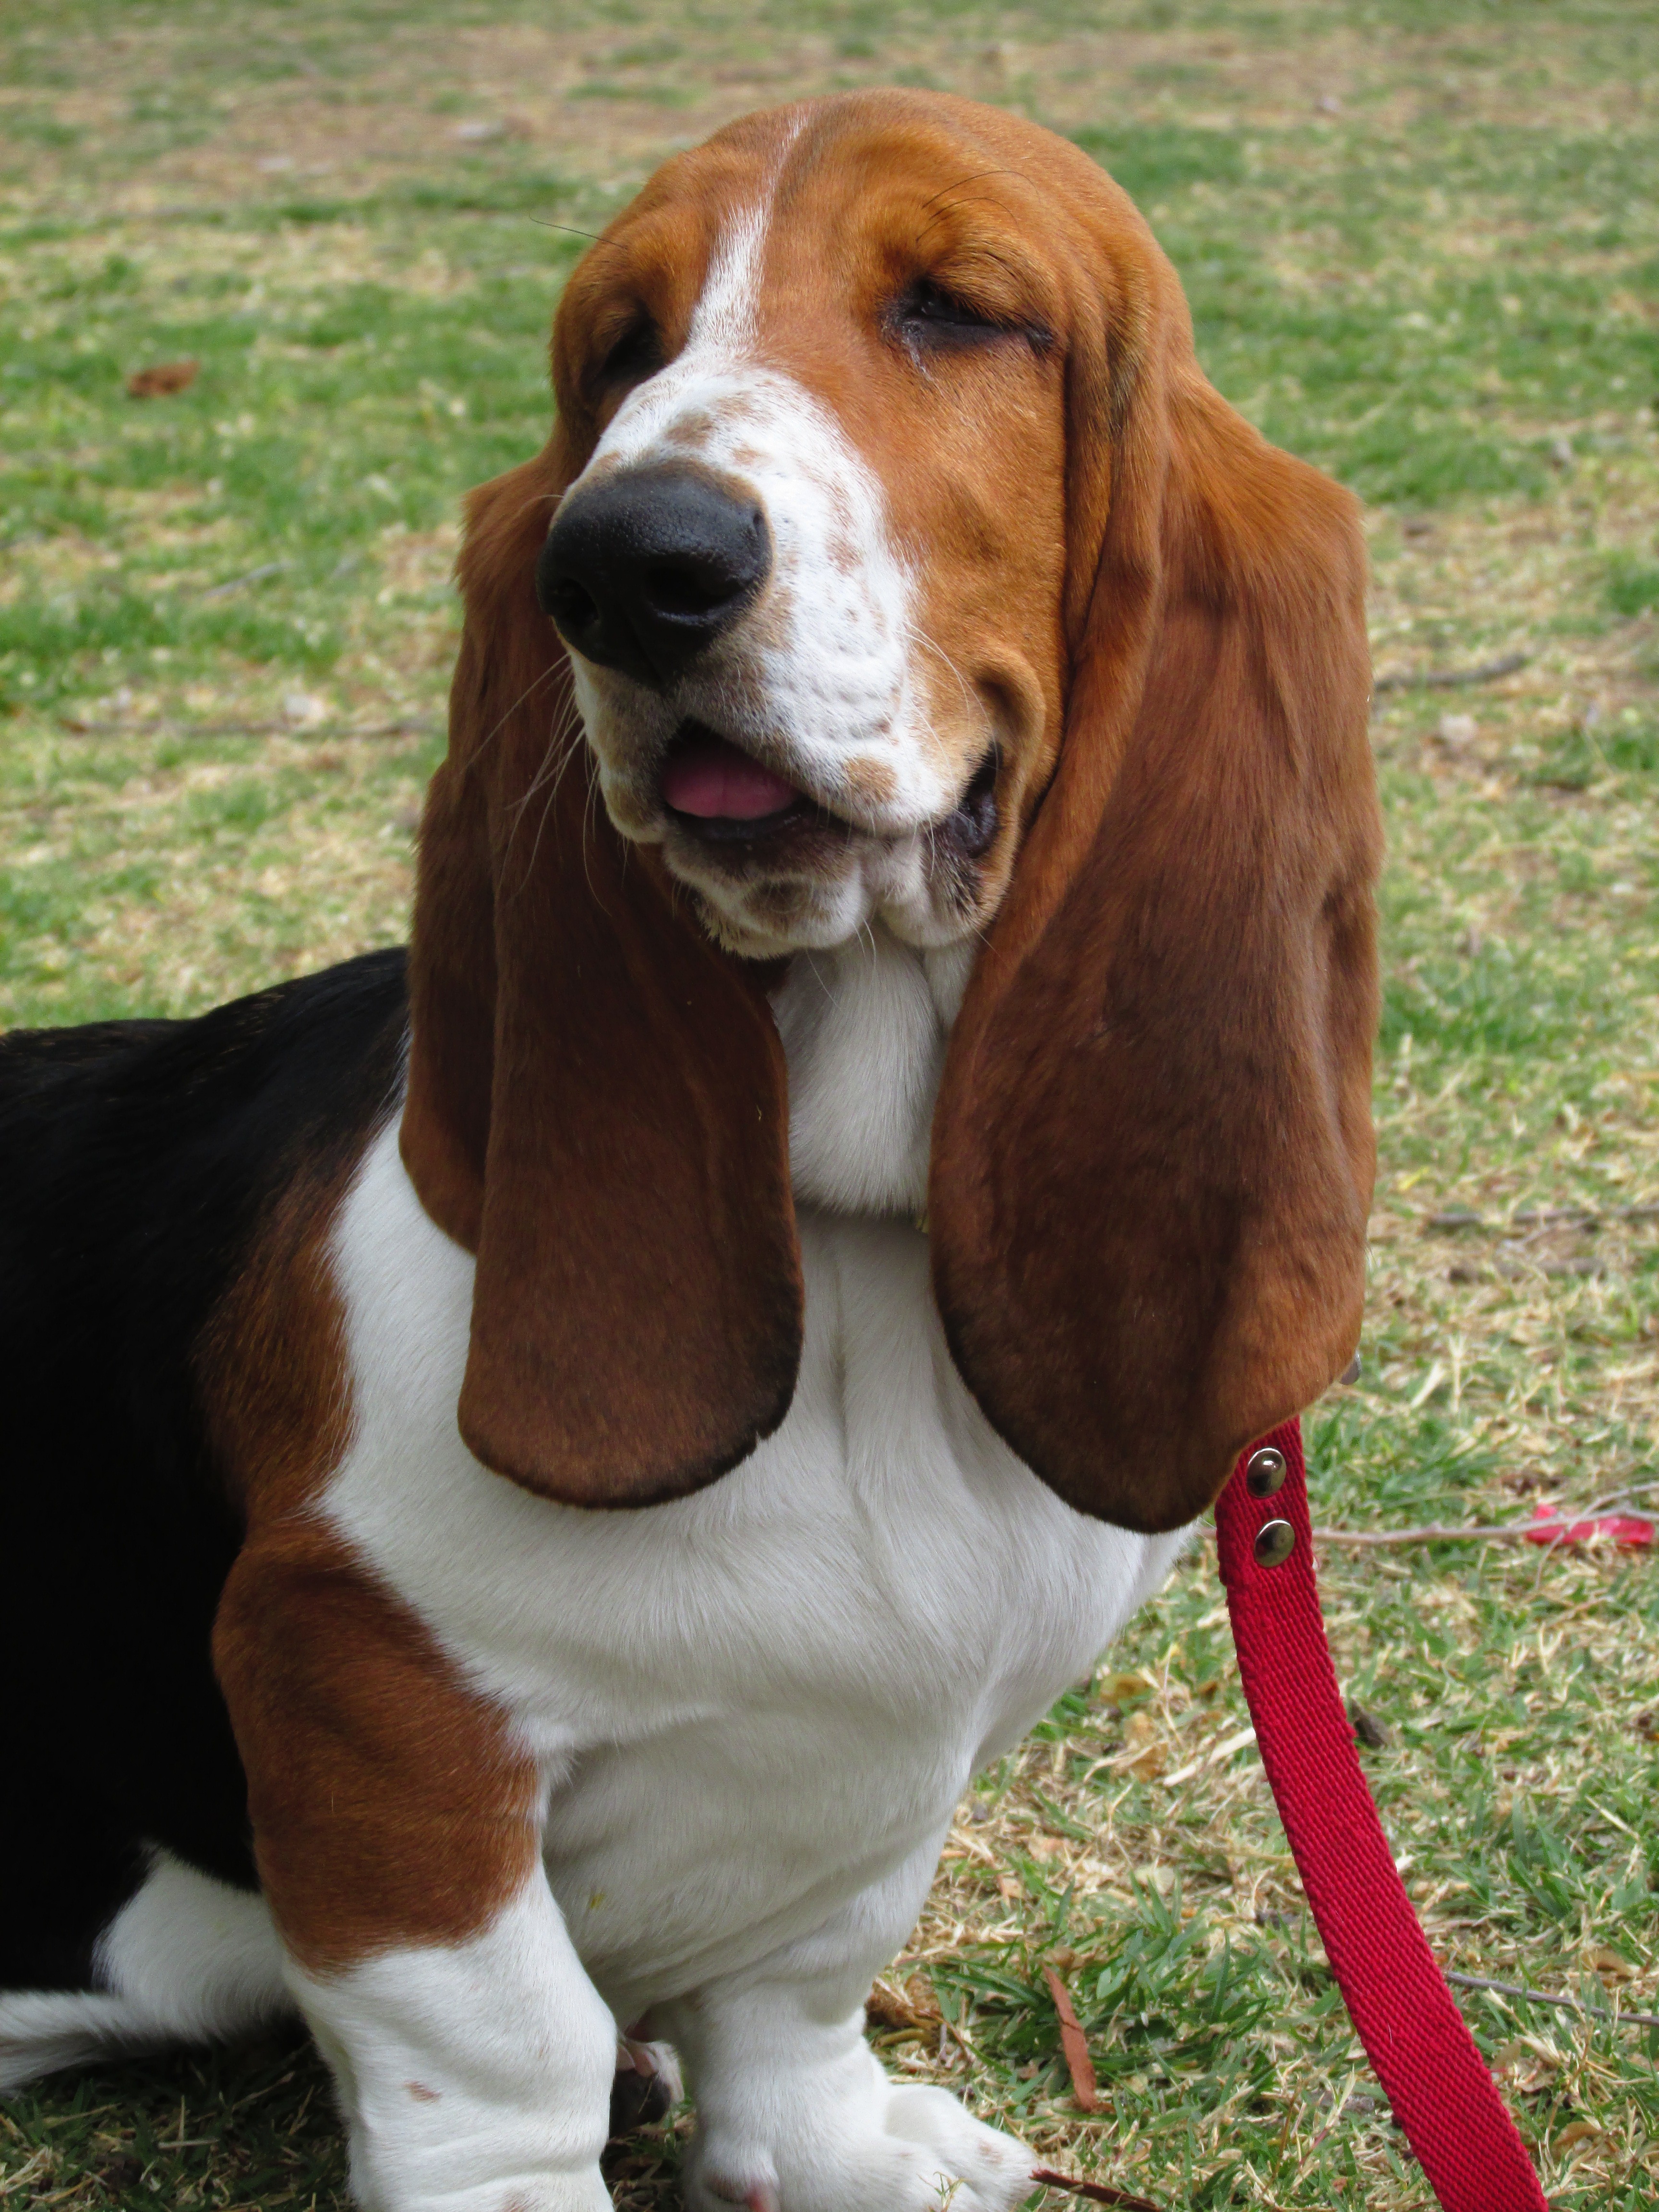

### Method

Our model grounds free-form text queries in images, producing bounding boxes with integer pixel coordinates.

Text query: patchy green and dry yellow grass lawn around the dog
[0,0,1659,2212]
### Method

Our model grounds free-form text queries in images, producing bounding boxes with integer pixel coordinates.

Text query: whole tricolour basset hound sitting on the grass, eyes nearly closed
[0,91,1380,2212]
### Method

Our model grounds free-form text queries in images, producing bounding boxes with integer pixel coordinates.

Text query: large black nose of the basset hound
[535,469,772,690]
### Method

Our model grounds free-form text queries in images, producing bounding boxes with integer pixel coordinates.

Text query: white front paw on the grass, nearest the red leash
[684,2084,1037,2212]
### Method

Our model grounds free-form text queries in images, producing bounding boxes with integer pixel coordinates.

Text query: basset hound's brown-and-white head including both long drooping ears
[403,93,1378,1528]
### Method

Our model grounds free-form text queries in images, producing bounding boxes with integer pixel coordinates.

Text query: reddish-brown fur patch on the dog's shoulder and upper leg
[197,1106,540,1973]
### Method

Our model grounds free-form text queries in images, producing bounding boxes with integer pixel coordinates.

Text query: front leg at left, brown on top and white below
[215,1533,617,2212]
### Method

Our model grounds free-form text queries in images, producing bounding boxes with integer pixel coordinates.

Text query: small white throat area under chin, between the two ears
[772,923,978,1216]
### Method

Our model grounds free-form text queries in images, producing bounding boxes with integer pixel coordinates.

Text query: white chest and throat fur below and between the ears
[327,925,1181,2020]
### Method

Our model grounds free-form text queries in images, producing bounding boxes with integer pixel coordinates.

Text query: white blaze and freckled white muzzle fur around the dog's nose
[571,179,956,863]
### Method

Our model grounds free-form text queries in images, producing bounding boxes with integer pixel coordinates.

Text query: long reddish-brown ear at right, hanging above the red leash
[929,228,1380,1528]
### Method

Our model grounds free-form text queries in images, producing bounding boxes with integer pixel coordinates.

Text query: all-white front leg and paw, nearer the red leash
[650,1842,1035,2212]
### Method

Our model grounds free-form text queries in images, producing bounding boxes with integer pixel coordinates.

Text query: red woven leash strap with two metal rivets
[1214,1420,1549,2212]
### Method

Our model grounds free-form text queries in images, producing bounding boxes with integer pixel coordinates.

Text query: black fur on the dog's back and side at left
[0,951,407,1989]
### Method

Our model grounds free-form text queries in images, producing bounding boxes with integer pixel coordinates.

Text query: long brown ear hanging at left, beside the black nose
[403,438,801,1506]
